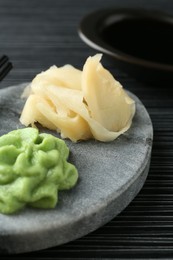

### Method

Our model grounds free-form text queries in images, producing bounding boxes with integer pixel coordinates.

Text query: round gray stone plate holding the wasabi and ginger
[0,84,153,253]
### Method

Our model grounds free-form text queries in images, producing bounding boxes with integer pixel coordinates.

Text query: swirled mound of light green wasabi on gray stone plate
[0,128,78,214]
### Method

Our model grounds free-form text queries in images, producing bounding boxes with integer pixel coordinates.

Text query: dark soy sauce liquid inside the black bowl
[101,18,173,65]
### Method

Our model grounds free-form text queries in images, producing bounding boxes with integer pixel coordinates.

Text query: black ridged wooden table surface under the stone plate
[0,0,173,259]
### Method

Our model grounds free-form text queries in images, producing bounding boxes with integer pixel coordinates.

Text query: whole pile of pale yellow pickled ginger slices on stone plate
[20,54,135,142]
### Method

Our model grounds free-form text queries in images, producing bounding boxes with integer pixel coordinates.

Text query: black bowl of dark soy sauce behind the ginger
[79,9,173,84]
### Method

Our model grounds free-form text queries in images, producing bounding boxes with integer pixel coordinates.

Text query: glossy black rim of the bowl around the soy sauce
[78,8,173,72]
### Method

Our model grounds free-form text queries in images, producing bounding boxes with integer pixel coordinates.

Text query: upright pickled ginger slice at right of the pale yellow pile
[82,54,135,132]
